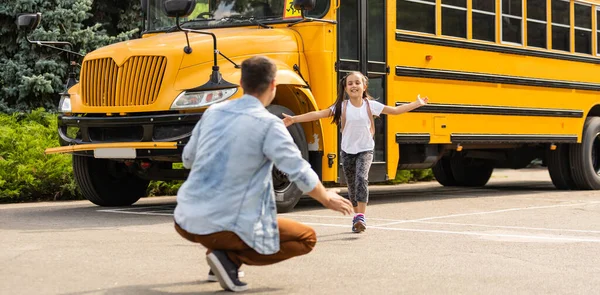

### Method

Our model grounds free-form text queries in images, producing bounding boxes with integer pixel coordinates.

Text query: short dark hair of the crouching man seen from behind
[242,56,277,94]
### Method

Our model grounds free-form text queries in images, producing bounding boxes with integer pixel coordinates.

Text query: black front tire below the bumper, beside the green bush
[73,155,150,207]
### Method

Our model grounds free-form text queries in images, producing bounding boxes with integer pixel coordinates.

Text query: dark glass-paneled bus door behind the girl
[336,0,388,183]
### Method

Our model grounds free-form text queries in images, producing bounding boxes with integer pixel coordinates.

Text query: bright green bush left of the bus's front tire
[0,109,81,203]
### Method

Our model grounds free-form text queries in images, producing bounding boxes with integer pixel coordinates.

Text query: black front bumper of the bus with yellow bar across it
[45,113,202,159]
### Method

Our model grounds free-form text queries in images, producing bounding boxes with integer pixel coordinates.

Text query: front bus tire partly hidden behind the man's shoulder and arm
[267,105,308,213]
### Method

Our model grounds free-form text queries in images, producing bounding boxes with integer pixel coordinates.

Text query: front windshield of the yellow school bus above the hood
[146,0,329,31]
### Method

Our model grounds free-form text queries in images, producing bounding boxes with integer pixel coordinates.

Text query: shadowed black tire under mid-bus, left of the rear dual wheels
[450,154,494,187]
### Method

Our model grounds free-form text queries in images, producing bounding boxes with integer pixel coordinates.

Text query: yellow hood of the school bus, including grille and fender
[69,27,305,113]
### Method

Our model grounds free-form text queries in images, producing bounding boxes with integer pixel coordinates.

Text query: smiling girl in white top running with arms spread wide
[283,72,428,233]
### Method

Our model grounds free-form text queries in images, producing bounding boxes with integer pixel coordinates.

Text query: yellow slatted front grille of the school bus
[81,56,167,107]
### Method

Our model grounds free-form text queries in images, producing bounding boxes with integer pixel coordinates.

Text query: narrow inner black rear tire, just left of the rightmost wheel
[546,144,577,190]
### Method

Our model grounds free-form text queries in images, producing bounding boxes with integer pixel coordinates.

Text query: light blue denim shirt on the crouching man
[175,95,319,255]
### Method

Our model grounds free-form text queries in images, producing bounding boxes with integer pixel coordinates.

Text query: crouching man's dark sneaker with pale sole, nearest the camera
[206,250,248,292]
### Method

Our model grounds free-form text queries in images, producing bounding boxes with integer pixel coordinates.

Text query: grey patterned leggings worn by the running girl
[341,151,373,207]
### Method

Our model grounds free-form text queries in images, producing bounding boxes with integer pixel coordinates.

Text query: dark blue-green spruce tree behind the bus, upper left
[0,0,141,112]
